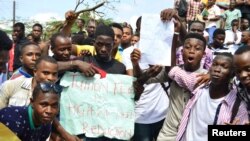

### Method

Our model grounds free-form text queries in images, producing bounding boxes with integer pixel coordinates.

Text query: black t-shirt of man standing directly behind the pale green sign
[83,56,126,74]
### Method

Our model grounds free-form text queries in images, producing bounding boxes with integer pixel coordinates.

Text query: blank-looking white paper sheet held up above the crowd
[139,14,174,66]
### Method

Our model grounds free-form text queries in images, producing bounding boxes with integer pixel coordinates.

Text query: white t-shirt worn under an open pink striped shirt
[182,88,224,141]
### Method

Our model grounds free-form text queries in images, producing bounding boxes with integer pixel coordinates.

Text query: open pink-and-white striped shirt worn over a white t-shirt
[169,67,248,141]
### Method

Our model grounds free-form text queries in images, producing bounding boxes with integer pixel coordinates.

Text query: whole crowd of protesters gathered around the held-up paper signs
[0,0,250,141]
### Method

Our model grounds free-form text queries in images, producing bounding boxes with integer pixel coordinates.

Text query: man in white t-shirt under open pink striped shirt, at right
[173,53,248,141]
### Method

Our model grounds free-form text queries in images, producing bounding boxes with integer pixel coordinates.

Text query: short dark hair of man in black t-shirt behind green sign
[95,25,115,40]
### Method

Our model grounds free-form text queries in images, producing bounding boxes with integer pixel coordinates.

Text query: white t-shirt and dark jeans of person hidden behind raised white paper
[122,16,169,141]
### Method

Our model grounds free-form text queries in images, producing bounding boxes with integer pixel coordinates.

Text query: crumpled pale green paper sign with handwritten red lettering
[60,72,134,140]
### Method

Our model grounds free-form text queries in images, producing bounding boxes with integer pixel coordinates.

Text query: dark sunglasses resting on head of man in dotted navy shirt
[39,82,63,94]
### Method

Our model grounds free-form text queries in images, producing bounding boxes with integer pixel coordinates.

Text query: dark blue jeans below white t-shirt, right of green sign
[133,119,165,141]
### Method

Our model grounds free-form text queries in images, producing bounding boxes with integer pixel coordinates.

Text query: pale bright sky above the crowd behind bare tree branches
[0,0,174,27]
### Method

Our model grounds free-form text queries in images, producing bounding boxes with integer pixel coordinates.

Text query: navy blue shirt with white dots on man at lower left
[0,106,51,141]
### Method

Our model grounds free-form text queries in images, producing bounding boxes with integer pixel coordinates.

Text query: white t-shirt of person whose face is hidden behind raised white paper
[122,43,169,124]
